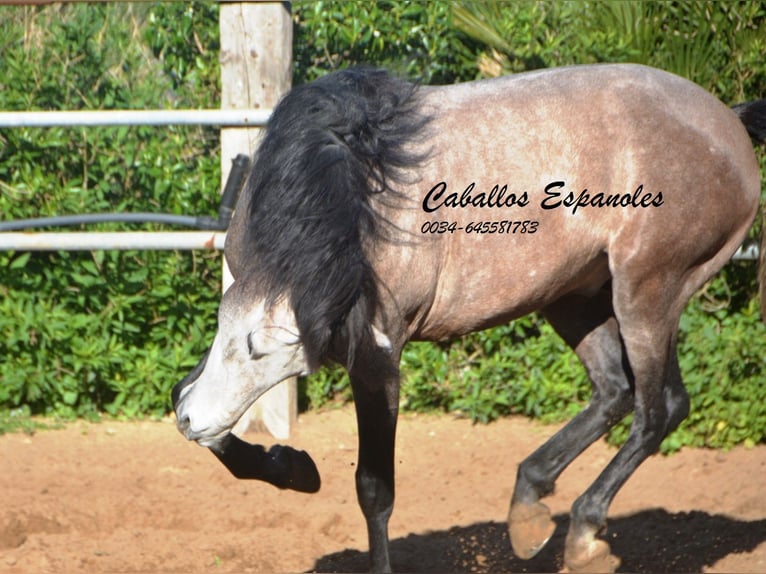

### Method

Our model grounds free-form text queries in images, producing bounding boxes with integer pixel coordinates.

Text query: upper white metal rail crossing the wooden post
[0,110,271,128]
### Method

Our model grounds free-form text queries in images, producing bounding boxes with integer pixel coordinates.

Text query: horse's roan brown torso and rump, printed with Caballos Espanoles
[374,65,760,339]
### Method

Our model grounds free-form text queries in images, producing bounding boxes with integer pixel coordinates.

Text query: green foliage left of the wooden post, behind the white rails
[0,3,220,424]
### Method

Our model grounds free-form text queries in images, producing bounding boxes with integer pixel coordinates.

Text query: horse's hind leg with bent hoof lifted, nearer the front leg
[508,286,633,559]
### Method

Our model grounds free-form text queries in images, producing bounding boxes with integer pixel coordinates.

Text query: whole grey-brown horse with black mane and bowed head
[173,65,766,571]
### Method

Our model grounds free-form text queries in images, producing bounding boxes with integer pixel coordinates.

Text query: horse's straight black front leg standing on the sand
[351,352,399,572]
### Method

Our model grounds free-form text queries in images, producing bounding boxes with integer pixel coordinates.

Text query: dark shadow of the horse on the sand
[314,509,766,573]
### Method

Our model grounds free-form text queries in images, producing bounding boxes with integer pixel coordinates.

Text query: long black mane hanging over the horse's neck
[246,68,427,366]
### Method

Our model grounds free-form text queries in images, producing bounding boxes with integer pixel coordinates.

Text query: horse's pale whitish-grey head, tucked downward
[173,281,310,447]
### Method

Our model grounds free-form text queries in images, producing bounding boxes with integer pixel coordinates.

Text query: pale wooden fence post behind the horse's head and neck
[219,2,297,439]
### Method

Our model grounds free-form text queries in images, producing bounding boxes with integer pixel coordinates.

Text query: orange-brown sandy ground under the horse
[0,408,766,573]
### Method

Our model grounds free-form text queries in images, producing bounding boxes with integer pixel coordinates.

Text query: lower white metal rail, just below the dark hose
[0,231,226,251]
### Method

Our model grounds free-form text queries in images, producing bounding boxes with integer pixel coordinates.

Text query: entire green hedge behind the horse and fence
[0,0,766,450]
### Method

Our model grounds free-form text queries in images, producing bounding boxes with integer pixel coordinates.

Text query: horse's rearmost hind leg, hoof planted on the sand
[564,278,689,572]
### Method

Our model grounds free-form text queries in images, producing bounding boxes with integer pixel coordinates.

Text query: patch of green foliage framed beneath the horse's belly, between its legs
[402,316,589,423]
